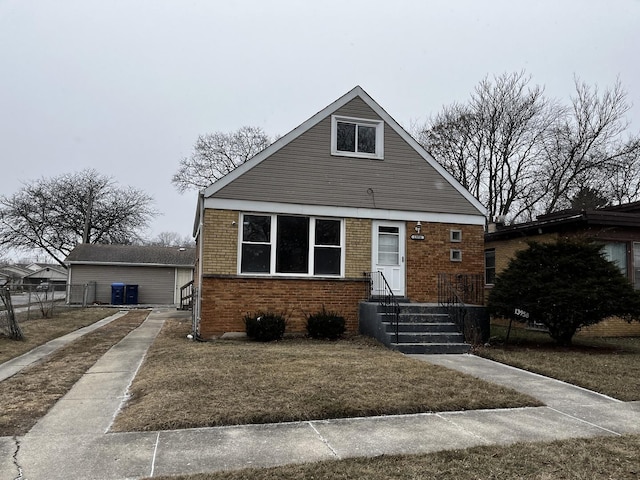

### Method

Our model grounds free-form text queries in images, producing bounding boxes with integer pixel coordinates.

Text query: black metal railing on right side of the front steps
[438,273,484,344]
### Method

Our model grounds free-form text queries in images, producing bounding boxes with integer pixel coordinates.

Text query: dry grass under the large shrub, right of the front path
[476,326,640,402]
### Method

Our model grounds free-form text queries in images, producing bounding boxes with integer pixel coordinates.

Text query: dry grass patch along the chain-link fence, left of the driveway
[0,307,118,363]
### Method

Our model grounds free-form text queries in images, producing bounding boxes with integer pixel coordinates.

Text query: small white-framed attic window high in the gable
[331,115,384,160]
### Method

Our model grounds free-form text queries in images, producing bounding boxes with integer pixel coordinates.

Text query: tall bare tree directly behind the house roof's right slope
[418,72,561,217]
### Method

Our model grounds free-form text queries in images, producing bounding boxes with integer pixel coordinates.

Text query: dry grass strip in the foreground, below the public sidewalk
[154,435,640,480]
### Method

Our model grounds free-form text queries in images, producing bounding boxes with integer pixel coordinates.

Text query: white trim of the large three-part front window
[237,212,346,278]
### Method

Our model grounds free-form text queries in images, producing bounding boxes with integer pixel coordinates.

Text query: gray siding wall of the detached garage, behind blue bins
[70,265,176,305]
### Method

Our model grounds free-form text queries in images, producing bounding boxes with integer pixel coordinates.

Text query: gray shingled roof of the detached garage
[65,243,196,267]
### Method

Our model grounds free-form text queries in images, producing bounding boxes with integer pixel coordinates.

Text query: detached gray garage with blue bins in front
[65,244,196,305]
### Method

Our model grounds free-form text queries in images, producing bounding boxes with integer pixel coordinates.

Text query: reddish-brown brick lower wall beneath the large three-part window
[200,276,367,339]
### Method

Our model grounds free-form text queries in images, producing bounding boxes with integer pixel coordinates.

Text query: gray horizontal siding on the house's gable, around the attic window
[212,98,478,215]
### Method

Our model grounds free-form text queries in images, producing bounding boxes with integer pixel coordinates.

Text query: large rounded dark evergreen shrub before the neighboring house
[488,240,640,345]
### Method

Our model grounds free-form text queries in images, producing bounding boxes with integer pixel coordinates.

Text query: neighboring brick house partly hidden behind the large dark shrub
[485,202,640,336]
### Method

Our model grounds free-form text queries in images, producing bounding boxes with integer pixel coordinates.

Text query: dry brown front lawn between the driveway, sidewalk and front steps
[114,320,540,431]
